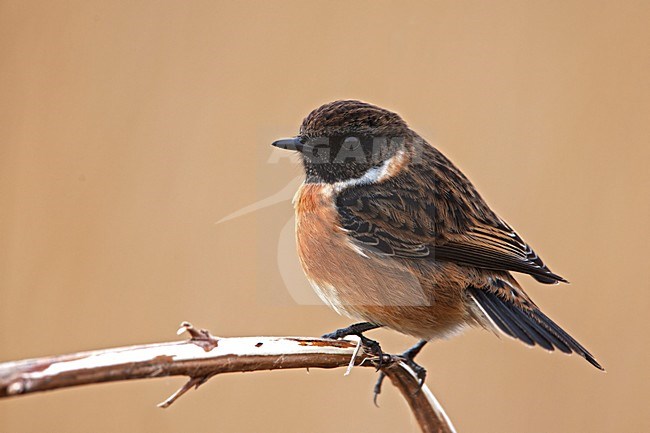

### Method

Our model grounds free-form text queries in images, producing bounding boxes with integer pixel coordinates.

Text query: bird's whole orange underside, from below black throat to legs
[295,185,467,339]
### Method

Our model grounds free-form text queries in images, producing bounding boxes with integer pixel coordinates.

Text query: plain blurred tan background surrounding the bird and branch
[0,1,650,433]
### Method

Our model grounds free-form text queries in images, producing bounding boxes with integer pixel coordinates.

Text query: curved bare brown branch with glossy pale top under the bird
[0,323,455,433]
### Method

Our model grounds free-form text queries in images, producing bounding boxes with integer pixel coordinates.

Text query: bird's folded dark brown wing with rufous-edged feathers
[337,143,566,284]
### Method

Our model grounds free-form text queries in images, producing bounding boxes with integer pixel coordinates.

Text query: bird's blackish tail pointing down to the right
[469,287,604,370]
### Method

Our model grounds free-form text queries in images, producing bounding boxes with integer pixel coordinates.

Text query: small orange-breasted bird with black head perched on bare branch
[272,100,604,398]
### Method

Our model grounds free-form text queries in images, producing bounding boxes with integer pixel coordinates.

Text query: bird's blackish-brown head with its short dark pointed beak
[273,100,410,183]
